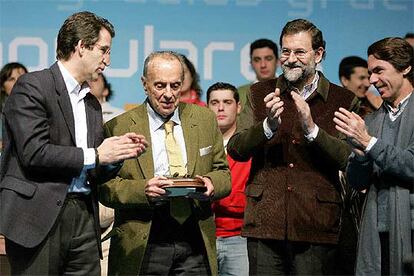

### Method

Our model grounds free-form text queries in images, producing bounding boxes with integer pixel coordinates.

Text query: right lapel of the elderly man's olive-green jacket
[179,104,199,176]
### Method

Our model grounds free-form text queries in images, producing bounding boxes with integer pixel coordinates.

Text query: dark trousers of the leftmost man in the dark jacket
[6,196,101,276]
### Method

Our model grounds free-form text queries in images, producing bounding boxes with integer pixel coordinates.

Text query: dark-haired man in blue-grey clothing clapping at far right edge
[334,37,414,275]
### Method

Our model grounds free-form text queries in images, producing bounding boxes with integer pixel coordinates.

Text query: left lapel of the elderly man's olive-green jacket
[129,104,154,179]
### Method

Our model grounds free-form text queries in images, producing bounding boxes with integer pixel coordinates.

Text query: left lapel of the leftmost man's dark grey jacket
[50,63,76,145]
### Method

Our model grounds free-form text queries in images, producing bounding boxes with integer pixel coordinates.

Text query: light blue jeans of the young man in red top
[216,236,249,276]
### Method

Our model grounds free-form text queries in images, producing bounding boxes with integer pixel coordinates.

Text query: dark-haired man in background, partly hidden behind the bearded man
[237,38,279,110]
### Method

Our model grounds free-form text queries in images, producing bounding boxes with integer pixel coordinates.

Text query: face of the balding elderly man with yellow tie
[141,56,183,118]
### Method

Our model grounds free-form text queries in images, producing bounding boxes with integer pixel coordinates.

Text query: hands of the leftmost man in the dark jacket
[97,132,148,165]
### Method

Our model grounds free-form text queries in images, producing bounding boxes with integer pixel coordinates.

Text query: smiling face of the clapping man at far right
[368,55,411,106]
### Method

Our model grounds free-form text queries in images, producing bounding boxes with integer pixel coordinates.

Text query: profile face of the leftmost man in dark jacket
[78,28,112,81]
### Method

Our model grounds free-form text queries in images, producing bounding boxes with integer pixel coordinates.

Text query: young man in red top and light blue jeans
[207,82,251,276]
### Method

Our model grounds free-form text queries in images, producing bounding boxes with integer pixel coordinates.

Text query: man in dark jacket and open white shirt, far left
[0,12,146,275]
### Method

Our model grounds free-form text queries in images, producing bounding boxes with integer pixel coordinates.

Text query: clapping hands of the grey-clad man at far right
[333,107,372,152]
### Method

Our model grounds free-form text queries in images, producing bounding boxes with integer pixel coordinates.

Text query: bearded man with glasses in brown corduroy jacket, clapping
[227,19,353,275]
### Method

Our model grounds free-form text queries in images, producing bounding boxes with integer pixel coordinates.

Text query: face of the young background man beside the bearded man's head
[250,47,277,81]
